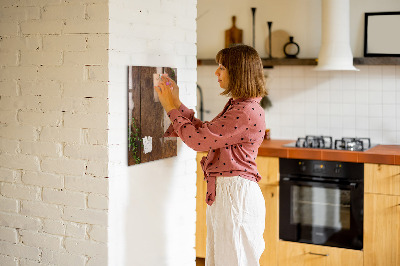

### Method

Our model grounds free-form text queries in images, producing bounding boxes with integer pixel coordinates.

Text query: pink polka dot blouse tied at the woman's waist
[164,97,265,205]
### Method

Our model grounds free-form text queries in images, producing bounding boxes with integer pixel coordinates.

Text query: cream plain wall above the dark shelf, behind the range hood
[197,0,400,59]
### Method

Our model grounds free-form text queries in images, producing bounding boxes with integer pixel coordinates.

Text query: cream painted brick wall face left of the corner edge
[0,0,109,266]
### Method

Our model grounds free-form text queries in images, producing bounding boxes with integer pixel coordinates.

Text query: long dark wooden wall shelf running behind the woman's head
[197,57,400,68]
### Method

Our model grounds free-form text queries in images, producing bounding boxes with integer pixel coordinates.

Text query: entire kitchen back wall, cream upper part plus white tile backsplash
[198,0,400,144]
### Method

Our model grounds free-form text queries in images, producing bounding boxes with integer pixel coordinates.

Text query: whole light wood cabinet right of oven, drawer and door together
[364,164,400,266]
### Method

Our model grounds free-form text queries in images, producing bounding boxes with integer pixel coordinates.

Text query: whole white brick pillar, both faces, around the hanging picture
[0,0,197,266]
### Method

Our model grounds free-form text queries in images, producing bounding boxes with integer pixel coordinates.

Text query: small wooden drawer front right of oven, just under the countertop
[364,163,400,196]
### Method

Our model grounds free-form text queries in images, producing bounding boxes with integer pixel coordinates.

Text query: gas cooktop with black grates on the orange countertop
[283,135,375,151]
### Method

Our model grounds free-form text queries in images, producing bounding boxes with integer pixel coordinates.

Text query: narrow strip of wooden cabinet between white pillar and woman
[196,152,207,258]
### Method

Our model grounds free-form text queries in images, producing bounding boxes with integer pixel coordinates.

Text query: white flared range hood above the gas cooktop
[314,0,359,71]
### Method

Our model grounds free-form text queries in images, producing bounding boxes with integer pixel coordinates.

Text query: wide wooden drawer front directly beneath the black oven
[278,241,363,266]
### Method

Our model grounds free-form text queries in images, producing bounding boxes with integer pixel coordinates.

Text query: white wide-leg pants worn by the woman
[206,176,265,266]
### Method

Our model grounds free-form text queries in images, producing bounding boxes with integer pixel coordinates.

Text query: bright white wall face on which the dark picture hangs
[108,0,197,266]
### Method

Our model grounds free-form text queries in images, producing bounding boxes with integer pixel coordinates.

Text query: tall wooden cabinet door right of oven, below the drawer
[364,194,400,266]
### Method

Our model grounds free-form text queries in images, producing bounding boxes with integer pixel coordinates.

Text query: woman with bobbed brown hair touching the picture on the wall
[155,45,266,266]
